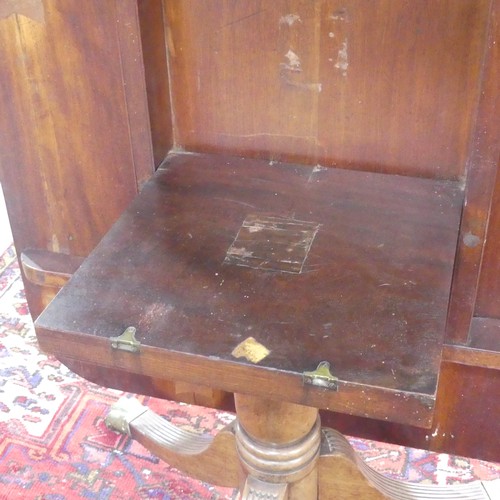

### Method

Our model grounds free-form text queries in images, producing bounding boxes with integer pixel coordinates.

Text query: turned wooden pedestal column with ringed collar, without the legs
[235,394,321,500]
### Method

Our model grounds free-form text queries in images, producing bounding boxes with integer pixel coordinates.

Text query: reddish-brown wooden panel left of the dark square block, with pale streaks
[0,0,153,316]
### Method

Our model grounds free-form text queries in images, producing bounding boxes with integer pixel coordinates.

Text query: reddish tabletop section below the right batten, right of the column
[322,362,500,462]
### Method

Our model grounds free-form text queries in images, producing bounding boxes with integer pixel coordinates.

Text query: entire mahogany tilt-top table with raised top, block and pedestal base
[0,0,500,500]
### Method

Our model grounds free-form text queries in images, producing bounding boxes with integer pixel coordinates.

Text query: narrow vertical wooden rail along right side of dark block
[447,0,500,344]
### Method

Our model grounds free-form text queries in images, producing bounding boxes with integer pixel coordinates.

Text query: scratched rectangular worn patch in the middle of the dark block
[224,215,320,274]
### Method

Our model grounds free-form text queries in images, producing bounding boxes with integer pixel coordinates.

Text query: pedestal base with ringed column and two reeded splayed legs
[106,394,500,500]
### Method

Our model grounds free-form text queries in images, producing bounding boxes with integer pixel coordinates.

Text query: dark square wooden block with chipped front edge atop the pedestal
[36,154,463,426]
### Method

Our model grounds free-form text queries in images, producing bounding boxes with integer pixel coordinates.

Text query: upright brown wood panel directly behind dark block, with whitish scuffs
[164,0,490,179]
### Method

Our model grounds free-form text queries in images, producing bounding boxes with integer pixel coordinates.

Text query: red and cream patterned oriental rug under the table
[0,247,500,500]
